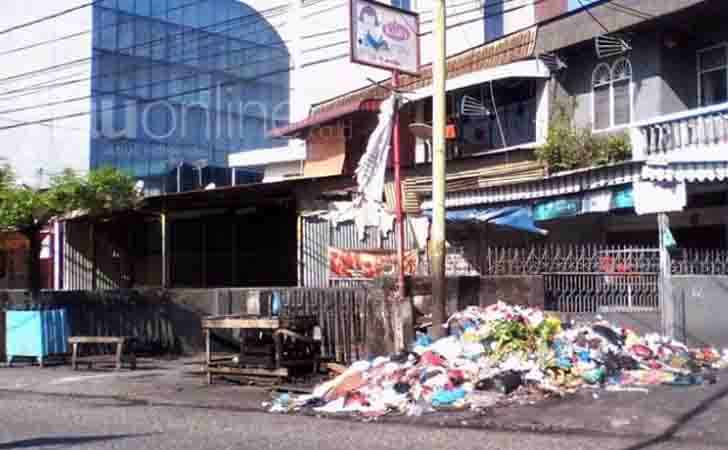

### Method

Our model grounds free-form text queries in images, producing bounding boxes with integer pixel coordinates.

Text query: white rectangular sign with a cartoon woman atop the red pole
[350,0,420,73]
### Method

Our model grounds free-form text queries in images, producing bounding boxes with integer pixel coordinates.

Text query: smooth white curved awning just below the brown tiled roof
[405,58,551,100]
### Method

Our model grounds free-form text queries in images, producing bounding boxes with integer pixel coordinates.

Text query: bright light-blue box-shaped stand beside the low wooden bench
[5,309,70,365]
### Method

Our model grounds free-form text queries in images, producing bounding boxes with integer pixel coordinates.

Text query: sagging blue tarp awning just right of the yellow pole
[425,206,548,236]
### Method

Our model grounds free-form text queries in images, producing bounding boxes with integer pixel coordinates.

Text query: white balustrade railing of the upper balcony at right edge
[630,103,728,162]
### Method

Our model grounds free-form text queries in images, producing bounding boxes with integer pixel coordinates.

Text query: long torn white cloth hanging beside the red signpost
[356,97,395,202]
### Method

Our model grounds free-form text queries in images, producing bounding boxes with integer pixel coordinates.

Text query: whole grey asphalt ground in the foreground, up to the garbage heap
[0,362,728,450]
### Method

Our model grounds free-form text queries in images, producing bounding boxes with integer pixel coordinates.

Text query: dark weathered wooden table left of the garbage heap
[202,315,320,384]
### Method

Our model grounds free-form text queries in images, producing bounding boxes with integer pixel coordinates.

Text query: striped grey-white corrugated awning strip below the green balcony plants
[422,162,642,209]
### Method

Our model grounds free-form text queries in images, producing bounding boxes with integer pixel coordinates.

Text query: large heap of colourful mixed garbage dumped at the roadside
[265,303,728,416]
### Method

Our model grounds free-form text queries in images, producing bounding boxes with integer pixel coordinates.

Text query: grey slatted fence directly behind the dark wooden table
[217,288,367,364]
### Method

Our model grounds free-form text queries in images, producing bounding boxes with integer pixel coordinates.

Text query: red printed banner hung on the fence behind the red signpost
[329,247,418,280]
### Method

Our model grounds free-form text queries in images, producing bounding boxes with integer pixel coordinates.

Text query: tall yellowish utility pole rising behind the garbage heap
[430,0,447,338]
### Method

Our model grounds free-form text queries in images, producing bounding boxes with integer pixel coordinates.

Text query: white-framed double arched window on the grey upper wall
[592,58,632,130]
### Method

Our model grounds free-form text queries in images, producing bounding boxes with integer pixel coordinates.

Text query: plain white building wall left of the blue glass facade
[0,0,92,186]
